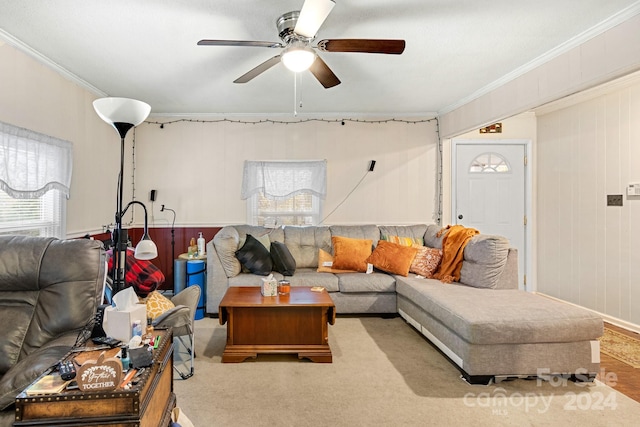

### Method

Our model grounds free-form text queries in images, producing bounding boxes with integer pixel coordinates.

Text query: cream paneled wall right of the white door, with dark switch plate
[536,79,640,325]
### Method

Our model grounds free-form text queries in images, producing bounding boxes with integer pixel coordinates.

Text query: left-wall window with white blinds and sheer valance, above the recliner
[0,122,72,238]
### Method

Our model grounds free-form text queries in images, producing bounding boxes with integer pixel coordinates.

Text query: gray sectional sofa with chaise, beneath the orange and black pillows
[206,224,604,383]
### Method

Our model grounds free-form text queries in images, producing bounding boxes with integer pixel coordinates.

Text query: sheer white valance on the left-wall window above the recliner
[0,122,73,199]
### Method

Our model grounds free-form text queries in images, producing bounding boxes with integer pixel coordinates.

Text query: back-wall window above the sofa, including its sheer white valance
[242,160,327,227]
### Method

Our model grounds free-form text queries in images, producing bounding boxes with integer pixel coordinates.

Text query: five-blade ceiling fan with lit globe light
[198,0,405,89]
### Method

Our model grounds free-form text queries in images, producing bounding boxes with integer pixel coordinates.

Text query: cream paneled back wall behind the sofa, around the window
[135,117,437,226]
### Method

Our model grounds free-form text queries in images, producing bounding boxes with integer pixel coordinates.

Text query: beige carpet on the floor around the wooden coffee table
[174,317,640,427]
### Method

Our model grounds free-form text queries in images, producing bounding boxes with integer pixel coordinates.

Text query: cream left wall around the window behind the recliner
[0,43,119,236]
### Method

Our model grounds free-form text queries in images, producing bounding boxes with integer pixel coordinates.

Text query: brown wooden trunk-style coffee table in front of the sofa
[219,286,336,363]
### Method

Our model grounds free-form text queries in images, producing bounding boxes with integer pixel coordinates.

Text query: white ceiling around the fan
[0,0,640,117]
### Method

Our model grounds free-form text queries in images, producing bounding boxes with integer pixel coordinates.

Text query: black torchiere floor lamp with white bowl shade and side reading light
[93,98,158,295]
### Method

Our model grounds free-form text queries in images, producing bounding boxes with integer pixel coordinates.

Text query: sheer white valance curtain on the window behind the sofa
[241,160,327,200]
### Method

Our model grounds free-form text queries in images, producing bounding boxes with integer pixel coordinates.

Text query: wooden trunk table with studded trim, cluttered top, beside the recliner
[13,329,176,427]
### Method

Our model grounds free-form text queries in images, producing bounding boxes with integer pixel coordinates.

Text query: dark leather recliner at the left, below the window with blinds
[0,236,106,426]
